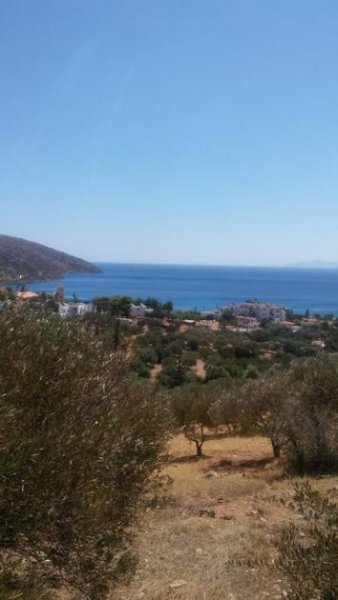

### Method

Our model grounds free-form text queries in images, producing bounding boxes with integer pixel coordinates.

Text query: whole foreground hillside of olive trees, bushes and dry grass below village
[0,292,338,600]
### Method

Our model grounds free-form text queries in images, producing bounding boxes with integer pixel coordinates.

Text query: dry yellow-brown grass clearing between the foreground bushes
[113,436,338,600]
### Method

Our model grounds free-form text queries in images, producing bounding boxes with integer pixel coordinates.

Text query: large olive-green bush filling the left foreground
[0,306,166,599]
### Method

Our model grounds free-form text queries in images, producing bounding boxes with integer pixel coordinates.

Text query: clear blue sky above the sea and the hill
[0,0,338,265]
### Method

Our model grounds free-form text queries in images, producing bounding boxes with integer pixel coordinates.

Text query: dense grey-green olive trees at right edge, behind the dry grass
[212,355,338,475]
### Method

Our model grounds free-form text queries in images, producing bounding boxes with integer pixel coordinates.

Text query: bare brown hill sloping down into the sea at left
[0,234,100,282]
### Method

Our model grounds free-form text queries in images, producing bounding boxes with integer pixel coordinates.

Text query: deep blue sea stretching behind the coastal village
[27,263,338,315]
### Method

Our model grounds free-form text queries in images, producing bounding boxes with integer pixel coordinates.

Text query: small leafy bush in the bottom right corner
[279,484,338,600]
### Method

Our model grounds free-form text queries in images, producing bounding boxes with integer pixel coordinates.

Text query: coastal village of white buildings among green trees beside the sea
[2,284,338,388]
